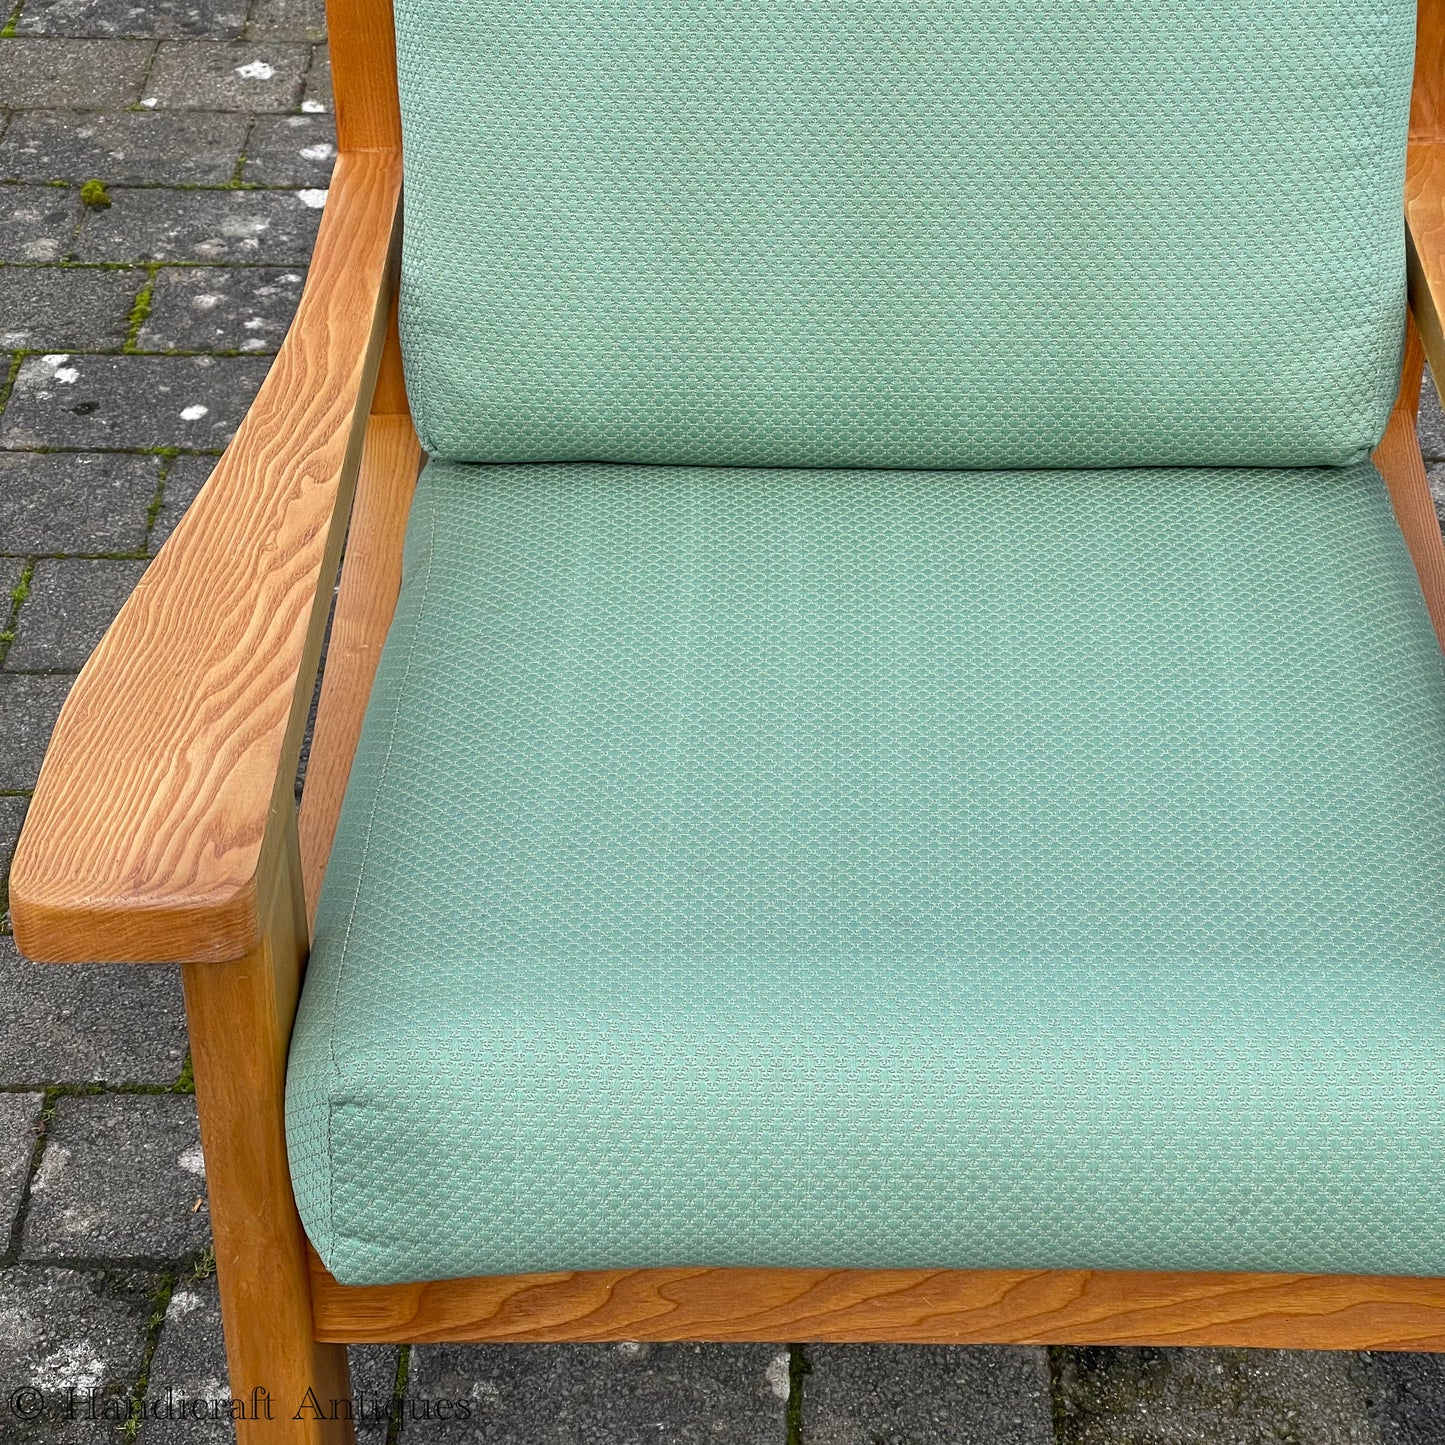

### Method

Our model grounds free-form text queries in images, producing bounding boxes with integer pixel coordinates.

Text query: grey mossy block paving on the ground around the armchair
[0,14,1445,1445]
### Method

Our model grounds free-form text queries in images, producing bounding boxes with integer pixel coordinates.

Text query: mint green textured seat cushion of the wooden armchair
[288,462,1445,1282]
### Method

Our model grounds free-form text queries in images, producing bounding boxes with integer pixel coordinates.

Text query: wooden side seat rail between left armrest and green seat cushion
[301,413,422,923]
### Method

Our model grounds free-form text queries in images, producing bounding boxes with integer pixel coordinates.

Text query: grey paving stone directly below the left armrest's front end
[0,936,186,1085]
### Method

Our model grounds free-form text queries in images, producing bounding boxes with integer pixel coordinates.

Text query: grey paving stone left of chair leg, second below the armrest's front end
[20,1094,211,1261]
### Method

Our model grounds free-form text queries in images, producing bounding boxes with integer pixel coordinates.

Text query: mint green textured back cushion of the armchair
[396,0,1415,467]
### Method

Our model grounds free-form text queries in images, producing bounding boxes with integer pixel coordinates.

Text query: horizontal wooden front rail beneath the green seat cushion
[311,1256,1445,1350]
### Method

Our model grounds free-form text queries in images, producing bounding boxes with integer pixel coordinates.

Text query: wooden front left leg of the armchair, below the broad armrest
[182,808,355,1445]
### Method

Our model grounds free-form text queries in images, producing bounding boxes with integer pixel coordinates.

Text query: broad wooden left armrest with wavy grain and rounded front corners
[10,150,400,962]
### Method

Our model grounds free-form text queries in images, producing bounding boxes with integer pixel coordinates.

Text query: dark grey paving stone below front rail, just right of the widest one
[803,1345,1053,1445]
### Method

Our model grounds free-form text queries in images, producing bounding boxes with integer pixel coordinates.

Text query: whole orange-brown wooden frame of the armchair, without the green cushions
[10,0,1445,1445]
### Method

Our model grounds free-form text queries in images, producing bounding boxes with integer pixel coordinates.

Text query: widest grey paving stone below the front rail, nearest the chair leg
[402,1345,788,1445]
